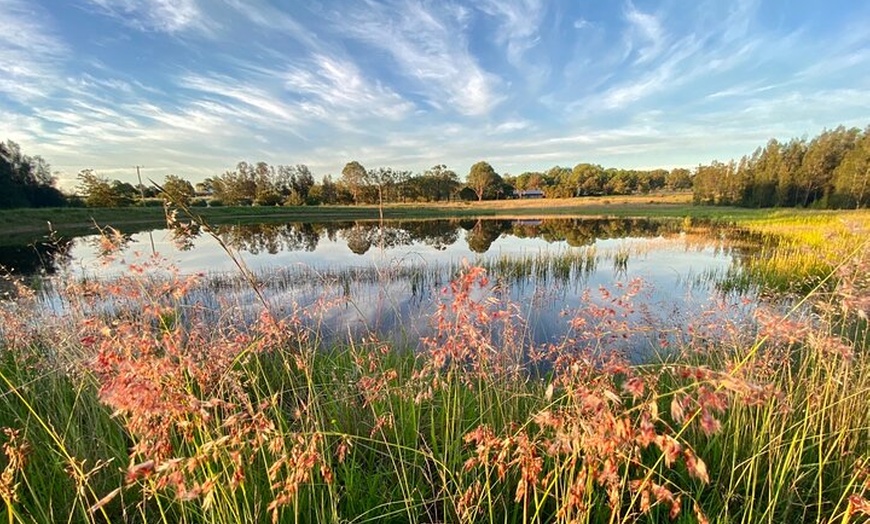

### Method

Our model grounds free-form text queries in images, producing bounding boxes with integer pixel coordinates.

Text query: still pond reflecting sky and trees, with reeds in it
[0,218,757,353]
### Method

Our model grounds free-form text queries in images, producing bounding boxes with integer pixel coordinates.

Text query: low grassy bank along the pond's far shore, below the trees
[0,193,864,244]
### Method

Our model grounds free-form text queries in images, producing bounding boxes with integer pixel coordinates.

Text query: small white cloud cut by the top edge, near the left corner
[84,0,208,34]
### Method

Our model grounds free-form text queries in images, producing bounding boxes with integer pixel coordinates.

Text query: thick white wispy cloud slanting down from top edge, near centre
[336,0,504,116]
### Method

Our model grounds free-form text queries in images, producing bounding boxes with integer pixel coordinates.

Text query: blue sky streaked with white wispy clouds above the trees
[0,0,870,189]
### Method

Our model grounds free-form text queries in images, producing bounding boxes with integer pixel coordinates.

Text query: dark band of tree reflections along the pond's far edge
[0,218,728,274]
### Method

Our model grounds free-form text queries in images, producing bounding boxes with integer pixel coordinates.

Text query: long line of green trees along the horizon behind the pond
[0,126,870,208]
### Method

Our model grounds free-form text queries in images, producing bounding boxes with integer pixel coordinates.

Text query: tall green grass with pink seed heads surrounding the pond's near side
[0,207,870,523]
